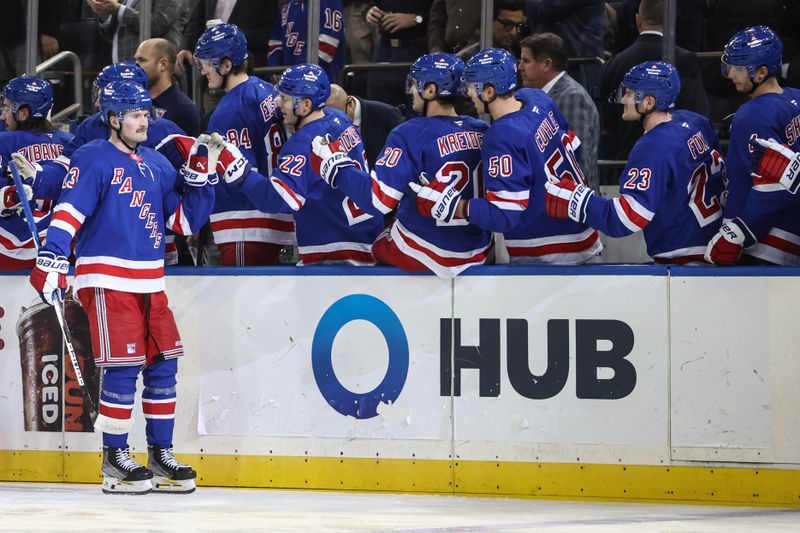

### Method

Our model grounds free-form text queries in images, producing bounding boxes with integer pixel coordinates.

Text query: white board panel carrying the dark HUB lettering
[454,276,669,459]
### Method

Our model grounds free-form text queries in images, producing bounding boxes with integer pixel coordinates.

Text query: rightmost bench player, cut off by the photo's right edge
[706,26,800,266]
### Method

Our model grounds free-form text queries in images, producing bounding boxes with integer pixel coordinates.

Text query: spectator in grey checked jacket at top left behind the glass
[86,0,187,63]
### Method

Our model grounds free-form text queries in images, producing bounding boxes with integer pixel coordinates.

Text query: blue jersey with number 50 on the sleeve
[468,89,603,264]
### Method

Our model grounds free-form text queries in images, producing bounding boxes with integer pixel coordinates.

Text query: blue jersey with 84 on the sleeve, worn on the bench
[208,77,295,244]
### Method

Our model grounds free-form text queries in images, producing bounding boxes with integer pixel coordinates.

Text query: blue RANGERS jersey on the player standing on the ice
[45,139,214,293]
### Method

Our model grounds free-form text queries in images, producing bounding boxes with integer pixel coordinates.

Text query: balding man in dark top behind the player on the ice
[136,38,201,137]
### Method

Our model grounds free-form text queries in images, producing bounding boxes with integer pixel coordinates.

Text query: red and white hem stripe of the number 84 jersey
[211,209,295,244]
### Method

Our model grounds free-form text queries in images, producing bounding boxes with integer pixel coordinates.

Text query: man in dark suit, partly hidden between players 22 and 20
[326,83,404,168]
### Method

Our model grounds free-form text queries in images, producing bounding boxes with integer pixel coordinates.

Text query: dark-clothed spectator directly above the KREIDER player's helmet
[428,0,481,53]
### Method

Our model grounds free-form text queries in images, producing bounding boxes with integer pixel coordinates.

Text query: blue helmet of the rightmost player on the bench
[721,26,783,80]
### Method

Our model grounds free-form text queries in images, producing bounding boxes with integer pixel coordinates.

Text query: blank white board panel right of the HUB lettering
[670,276,800,463]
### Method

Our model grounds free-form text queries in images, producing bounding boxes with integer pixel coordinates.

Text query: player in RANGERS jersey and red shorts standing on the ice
[31,82,216,494]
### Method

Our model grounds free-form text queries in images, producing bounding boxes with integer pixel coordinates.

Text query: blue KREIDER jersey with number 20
[336,116,492,278]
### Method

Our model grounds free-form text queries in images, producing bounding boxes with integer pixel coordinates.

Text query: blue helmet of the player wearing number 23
[616,61,681,111]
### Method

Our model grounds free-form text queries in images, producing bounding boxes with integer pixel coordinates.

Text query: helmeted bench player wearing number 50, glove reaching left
[406,48,603,264]
